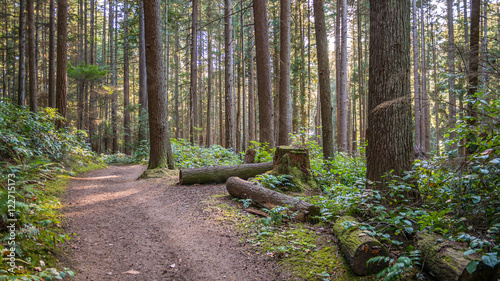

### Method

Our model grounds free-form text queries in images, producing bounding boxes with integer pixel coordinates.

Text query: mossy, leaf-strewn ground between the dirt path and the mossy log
[204,195,375,280]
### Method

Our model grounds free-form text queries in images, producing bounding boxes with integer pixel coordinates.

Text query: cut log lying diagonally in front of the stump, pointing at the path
[226,177,319,221]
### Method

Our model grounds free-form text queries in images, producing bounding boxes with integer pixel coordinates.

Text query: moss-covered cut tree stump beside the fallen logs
[271,146,317,191]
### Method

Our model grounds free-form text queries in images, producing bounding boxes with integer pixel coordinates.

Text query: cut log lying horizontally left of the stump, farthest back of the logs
[179,162,273,185]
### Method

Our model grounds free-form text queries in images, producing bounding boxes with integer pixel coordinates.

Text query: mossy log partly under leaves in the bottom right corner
[417,232,500,281]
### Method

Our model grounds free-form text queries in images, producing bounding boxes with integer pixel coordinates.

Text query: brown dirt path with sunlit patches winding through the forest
[63,165,283,281]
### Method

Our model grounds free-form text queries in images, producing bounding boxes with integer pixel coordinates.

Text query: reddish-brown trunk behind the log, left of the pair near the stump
[253,0,275,147]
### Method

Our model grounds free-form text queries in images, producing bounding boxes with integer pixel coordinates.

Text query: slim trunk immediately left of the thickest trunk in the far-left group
[48,0,55,108]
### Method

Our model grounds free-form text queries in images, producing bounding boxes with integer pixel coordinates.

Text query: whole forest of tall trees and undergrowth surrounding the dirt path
[0,0,500,280]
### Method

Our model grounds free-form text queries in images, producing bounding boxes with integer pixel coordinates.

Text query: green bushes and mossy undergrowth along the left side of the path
[0,100,104,280]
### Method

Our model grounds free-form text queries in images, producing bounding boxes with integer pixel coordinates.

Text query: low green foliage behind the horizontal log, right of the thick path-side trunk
[171,139,242,169]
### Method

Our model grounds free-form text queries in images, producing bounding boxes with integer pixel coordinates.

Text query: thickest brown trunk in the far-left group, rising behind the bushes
[56,0,68,127]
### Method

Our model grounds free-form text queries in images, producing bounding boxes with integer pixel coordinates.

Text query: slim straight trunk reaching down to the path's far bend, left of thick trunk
[123,0,132,155]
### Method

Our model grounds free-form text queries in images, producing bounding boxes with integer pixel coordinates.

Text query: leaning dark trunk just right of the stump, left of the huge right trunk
[313,0,334,159]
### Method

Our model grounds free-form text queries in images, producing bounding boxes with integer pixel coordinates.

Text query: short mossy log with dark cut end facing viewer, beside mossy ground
[333,216,388,276]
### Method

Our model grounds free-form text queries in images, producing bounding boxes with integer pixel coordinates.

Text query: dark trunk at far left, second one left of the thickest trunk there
[28,0,38,112]
